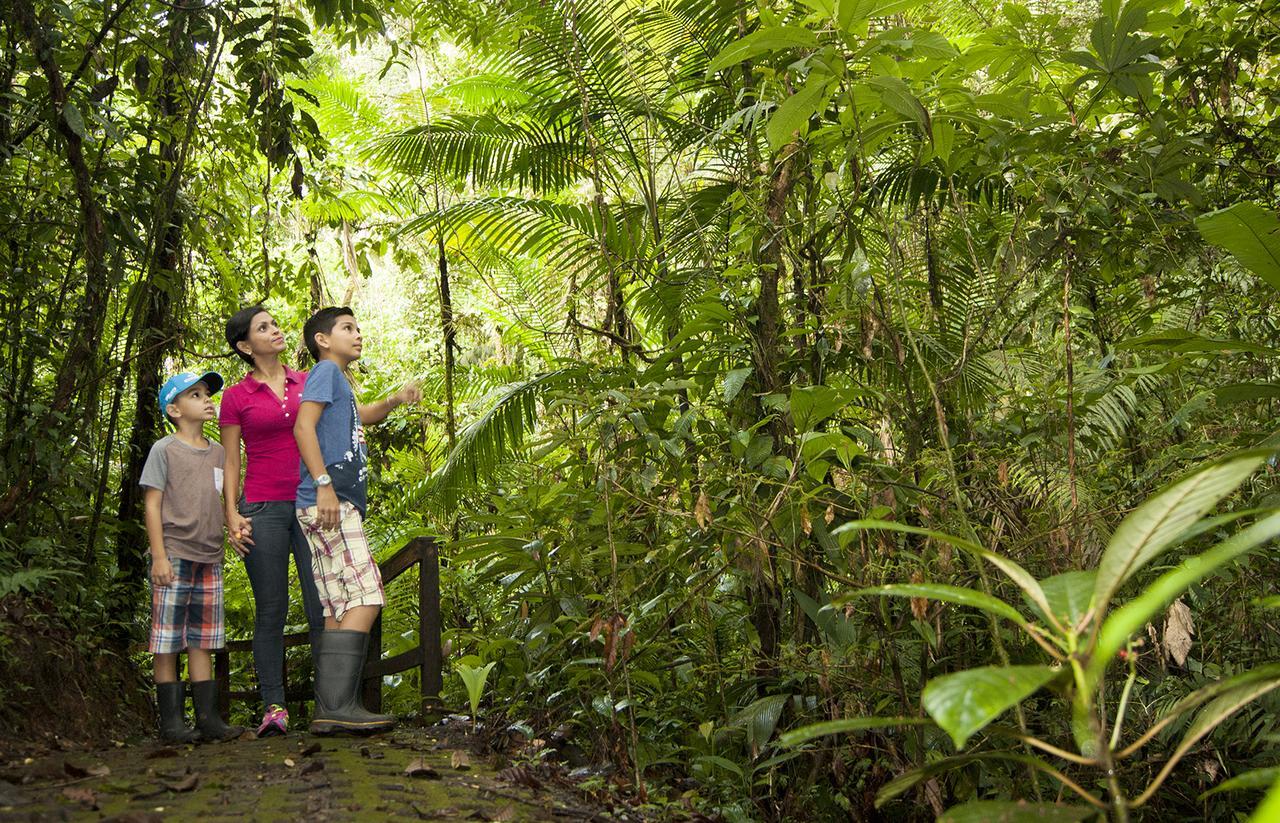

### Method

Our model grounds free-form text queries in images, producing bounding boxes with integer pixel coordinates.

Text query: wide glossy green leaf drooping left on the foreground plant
[920,666,1059,749]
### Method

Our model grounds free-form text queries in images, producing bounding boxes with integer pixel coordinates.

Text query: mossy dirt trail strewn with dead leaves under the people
[0,728,625,823]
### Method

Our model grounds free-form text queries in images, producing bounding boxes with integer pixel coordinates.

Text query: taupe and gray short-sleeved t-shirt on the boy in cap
[138,434,225,563]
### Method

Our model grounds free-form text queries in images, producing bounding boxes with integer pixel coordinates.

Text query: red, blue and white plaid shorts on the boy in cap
[150,557,227,654]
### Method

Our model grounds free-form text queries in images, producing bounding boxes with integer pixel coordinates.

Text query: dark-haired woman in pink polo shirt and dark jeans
[219,306,324,737]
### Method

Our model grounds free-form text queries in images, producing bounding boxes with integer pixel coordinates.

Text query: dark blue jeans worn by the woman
[239,500,324,709]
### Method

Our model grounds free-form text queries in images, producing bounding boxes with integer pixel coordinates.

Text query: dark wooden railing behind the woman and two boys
[214,538,444,717]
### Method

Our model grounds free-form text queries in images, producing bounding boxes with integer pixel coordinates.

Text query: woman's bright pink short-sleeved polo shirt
[218,366,307,503]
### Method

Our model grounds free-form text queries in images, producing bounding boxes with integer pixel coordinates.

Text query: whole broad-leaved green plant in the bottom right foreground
[780,449,1280,820]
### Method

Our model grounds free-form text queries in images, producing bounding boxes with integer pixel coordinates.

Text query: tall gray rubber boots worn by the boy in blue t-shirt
[311,628,396,735]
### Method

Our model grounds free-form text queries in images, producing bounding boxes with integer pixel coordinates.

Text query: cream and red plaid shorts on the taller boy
[297,500,387,621]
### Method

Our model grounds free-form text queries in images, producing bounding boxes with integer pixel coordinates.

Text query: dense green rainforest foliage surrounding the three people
[0,0,1280,820]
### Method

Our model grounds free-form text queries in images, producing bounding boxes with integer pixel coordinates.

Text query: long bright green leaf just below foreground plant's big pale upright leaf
[1085,512,1280,692]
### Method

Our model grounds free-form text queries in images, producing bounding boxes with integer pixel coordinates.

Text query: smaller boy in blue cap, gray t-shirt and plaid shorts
[138,371,244,742]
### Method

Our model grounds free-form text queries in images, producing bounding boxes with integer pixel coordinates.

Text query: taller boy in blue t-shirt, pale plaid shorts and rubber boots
[293,307,422,735]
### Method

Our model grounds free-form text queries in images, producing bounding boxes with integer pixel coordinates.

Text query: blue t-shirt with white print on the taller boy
[294,360,369,517]
